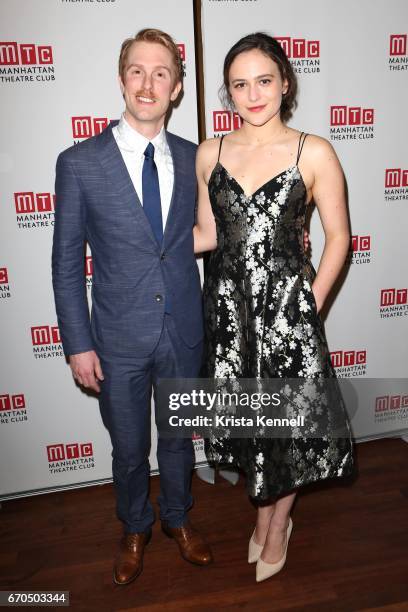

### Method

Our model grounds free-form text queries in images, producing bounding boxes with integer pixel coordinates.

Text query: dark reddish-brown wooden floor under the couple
[0,439,408,612]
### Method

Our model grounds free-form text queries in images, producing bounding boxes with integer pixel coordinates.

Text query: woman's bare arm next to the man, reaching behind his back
[193,140,218,253]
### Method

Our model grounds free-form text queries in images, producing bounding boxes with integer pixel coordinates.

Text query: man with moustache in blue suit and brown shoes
[52,29,212,584]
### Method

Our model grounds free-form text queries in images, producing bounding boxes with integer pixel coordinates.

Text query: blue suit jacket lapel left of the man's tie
[97,122,159,248]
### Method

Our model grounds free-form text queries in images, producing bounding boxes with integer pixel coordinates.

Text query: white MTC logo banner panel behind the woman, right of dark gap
[202,0,408,440]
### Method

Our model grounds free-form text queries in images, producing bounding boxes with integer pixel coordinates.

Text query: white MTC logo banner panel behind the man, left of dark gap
[0,0,207,498]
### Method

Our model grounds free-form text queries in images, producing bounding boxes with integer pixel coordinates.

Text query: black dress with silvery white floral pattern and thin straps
[203,134,353,500]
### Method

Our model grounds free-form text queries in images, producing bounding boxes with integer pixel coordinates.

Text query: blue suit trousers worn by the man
[99,314,202,533]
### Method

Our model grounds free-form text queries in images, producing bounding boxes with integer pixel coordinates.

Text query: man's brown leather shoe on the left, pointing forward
[113,530,152,584]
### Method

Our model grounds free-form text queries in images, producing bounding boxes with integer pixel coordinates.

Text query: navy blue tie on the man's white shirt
[142,142,163,245]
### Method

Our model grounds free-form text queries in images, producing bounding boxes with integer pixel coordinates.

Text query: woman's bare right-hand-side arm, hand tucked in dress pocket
[306,136,350,311]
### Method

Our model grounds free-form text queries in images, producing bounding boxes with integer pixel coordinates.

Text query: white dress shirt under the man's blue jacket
[112,114,174,231]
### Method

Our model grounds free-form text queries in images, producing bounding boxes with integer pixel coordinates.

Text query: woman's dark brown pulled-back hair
[219,32,297,122]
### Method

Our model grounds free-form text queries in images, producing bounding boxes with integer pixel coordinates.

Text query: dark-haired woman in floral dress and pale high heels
[194,33,353,581]
